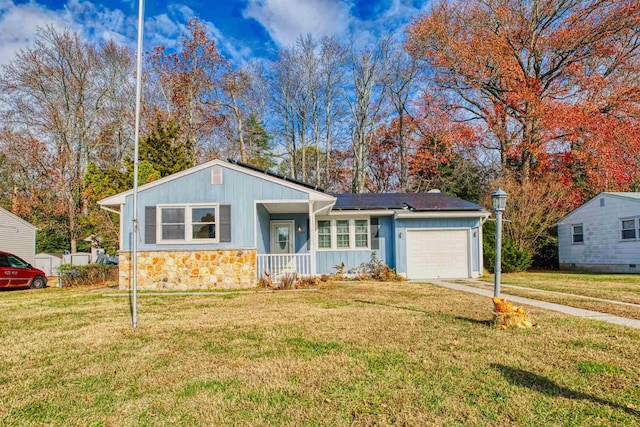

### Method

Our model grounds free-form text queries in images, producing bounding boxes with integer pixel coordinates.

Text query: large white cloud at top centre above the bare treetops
[243,0,351,46]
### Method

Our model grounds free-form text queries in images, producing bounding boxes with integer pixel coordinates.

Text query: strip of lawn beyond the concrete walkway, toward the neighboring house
[483,271,640,319]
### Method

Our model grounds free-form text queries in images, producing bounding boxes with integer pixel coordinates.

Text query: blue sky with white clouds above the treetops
[0,0,428,64]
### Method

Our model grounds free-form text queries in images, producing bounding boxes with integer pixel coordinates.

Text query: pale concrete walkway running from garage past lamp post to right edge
[426,279,640,329]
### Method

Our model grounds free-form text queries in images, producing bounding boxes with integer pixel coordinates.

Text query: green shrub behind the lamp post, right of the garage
[482,221,532,273]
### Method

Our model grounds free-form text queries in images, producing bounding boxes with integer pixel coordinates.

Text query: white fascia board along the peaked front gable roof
[98,159,336,206]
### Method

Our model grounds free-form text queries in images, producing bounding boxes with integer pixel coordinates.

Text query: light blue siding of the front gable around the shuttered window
[121,166,309,251]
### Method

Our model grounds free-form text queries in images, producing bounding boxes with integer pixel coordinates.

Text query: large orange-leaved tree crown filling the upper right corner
[406,0,640,192]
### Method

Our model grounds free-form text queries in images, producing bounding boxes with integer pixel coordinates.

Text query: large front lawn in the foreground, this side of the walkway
[0,283,640,426]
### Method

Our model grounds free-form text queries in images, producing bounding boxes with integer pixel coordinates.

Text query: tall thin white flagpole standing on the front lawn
[131,0,144,329]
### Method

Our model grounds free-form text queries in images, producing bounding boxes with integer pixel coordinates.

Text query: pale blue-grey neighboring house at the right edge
[557,192,640,273]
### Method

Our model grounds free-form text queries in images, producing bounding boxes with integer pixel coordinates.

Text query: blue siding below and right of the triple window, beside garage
[316,216,395,274]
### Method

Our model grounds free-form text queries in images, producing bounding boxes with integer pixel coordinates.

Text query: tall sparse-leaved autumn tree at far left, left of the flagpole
[0,27,133,252]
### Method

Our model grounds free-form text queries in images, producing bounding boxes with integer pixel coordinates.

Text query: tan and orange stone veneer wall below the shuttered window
[119,249,257,290]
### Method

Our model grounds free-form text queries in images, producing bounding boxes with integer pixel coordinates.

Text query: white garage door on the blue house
[407,230,469,279]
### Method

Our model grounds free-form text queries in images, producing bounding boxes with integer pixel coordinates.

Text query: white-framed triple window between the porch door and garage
[316,218,371,250]
